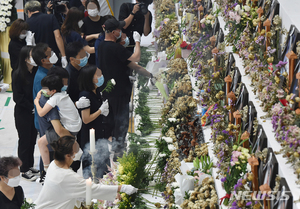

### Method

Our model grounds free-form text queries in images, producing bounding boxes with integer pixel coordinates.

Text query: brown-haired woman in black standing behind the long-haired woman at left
[8,19,29,72]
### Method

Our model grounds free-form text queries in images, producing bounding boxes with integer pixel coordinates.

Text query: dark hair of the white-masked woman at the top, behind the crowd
[61,7,84,38]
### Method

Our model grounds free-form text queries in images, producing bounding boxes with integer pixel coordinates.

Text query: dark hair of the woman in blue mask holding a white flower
[78,65,97,91]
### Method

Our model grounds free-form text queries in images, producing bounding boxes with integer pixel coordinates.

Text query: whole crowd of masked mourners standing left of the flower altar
[0,0,155,209]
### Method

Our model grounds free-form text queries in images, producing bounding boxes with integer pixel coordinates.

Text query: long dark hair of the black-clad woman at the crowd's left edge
[14,46,34,85]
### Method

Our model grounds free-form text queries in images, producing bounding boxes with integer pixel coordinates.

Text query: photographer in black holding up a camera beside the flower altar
[119,0,152,52]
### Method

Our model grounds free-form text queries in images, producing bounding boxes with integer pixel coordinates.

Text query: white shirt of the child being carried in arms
[47,91,82,132]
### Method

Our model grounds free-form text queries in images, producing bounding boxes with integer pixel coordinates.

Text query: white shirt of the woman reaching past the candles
[34,161,118,209]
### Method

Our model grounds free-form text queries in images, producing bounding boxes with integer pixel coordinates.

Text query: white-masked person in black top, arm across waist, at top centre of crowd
[81,0,107,65]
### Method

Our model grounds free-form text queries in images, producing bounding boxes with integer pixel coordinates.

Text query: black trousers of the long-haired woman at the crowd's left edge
[14,106,37,172]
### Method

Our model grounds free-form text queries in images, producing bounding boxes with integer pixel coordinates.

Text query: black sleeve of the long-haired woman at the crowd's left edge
[12,72,34,111]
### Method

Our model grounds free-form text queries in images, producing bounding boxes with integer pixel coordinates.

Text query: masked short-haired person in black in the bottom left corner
[0,157,24,209]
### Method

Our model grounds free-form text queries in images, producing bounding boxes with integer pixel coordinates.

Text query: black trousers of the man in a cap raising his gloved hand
[108,95,130,152]
